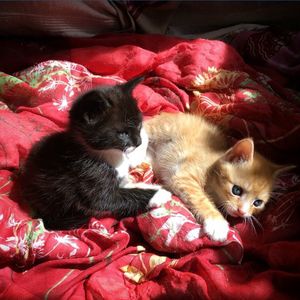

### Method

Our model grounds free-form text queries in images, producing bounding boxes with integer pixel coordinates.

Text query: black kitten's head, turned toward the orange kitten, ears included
[70,77,142,151]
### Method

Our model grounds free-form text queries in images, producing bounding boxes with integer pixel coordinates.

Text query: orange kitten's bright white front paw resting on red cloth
[203,219,229,242]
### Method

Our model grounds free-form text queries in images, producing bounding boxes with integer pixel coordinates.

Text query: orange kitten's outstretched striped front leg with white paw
[171,178,229,242]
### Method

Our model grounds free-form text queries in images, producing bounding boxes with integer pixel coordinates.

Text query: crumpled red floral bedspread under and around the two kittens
[0,35,300,300]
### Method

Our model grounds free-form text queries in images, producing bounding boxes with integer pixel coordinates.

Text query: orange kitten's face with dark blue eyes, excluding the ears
[211,157,274,217]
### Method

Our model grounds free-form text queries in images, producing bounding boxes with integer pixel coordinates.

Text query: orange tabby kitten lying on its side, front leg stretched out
[144,113,287,241]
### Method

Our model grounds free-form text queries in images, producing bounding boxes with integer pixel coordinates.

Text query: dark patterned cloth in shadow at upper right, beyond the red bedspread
[231,27,300,92]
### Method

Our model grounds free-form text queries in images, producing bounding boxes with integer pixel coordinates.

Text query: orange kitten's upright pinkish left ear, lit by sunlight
[224,138,254,163]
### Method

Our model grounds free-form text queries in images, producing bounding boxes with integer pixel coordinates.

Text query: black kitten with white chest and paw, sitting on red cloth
[20,79,169,229]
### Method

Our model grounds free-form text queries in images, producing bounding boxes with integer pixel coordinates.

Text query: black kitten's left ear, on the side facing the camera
[70,90,112,125]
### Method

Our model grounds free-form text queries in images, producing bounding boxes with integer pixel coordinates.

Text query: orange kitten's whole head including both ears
[207,138,292,217]
